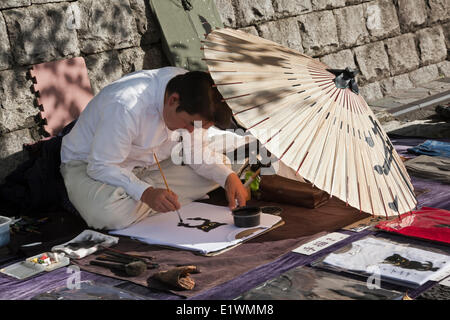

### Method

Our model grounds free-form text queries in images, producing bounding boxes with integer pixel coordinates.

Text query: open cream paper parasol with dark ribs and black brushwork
[202,29,417,217]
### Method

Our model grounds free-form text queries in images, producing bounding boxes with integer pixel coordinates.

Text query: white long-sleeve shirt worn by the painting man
[61,67,233,200]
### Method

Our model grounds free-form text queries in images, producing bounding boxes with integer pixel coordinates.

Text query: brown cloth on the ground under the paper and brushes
[72,198,369,297]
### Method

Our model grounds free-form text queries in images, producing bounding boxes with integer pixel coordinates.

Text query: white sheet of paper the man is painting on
[110,202,281,254]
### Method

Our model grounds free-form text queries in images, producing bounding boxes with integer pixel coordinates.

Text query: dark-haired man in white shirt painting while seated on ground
[61,67,247,230]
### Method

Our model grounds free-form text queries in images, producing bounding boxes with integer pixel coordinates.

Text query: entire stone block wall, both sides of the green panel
[0,0,450,180]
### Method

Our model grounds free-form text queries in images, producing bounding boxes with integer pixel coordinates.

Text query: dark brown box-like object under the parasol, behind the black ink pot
[259,175,330,209]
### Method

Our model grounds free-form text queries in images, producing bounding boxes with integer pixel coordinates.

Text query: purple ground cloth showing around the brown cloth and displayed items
[0,138,450,300]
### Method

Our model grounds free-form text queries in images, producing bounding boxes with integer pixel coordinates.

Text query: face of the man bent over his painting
[163,93,213,133]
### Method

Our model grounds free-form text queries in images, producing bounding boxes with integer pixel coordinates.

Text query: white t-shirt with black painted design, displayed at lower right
[323,237,450,287]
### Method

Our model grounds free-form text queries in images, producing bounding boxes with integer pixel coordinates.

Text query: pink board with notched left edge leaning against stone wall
[30,57,94,136]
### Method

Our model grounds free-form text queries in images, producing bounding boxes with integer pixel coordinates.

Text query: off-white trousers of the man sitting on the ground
[60,159,219,230]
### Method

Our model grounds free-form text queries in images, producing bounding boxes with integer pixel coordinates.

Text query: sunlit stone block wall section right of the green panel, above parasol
[216,0,450,102]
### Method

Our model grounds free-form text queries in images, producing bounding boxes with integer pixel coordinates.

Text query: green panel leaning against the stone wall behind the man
[149,0,223,71]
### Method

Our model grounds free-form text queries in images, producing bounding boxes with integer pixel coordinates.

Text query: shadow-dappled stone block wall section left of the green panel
[0,0,169,180]
